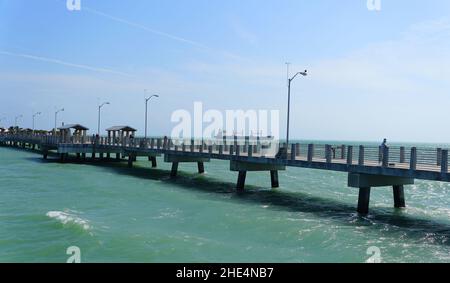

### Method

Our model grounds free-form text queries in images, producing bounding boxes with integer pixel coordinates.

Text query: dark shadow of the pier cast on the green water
[21,152,450,246]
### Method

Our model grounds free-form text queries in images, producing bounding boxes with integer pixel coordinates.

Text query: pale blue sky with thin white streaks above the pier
[0,0,450,143]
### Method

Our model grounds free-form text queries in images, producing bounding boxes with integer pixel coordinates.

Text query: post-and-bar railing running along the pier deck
[0,134,449,173]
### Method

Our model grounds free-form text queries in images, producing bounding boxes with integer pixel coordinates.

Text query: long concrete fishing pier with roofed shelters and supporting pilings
[0,130,450,215]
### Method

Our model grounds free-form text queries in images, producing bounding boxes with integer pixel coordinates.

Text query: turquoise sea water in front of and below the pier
[0,148,450,262]
